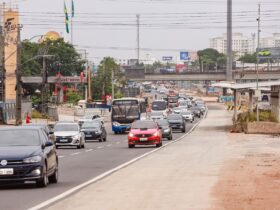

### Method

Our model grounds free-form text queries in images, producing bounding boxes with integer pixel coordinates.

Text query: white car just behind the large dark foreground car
[53,122,85,149]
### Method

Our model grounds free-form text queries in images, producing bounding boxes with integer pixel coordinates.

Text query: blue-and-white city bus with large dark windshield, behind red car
[111,98,146,134]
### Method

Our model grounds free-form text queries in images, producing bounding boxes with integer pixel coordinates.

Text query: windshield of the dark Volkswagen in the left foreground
[0,129,40,147]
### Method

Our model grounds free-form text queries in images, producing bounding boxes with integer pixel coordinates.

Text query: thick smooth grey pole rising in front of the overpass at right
[226,0,233,81]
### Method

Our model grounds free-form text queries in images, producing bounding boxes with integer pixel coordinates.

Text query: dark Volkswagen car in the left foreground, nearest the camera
[0,126,58,187]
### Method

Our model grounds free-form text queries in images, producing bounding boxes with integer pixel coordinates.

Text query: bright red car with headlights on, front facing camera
[128,120,162,148]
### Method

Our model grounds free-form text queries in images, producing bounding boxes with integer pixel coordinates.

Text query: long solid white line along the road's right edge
[28,115,203,210]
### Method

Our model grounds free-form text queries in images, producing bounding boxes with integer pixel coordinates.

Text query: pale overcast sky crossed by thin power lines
[2,0,280,63]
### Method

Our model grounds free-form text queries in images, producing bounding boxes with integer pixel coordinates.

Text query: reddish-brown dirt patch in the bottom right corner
[211,135,280,210]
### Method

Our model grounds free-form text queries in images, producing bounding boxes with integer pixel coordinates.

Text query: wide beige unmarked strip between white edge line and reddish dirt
[46,105,232,210]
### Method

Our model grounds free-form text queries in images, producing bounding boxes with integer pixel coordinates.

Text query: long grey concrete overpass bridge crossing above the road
[125,69,280,82]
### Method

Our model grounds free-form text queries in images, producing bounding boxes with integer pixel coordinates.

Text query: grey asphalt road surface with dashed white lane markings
[0,116,201,210]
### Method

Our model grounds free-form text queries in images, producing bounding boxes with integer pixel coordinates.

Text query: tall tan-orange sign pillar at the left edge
[4,9,19,102]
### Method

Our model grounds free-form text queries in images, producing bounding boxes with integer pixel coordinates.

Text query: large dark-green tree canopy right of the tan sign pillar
[21,39,85,76]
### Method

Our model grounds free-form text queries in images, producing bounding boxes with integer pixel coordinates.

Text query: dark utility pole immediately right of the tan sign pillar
[16,25,22,125]
